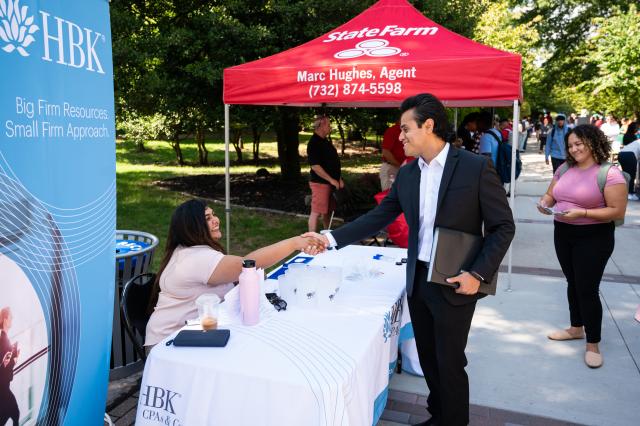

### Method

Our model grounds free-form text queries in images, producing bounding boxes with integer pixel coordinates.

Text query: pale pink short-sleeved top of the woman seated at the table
[144,246,233,346]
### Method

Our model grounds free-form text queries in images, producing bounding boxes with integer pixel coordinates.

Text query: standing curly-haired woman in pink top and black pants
[538,125,627,368]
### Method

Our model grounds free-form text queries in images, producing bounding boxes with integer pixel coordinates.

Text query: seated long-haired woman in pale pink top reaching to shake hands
[144,200,324,350]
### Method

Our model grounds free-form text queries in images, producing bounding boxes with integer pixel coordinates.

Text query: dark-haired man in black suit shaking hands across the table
[310,94,515,426]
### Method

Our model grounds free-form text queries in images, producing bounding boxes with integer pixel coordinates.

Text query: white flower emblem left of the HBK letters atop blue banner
[0,0,40,56]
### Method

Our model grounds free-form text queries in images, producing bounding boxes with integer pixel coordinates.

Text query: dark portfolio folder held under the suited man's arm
[427,227,498,295]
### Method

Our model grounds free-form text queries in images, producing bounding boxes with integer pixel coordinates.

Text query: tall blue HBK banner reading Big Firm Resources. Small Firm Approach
[0,0,116,425]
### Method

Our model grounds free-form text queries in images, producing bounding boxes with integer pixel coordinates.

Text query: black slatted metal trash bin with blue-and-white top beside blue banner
[109,230,159,379]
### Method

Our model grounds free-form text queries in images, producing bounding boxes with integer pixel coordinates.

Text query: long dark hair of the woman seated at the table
[148,199,225,312]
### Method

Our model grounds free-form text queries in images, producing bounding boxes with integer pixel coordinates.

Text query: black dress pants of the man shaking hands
[409,262,476,426]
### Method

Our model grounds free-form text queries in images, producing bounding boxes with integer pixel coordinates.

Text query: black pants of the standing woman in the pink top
[553,221,615,343]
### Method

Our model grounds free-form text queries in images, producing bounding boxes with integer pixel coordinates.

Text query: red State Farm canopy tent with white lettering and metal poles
[223,0,522,286]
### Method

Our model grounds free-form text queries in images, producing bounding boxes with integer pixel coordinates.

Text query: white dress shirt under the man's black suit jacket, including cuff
[325,143,449,262]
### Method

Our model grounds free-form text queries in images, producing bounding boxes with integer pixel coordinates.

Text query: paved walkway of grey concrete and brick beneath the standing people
[102,137,640,426]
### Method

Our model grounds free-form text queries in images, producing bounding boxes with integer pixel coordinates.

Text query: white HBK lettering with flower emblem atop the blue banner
[0,0,106,74]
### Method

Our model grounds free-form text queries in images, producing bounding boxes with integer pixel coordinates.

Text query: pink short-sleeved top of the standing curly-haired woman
[553,164,626,225]
